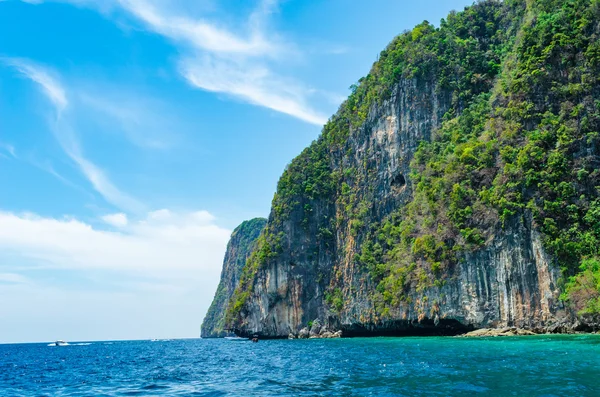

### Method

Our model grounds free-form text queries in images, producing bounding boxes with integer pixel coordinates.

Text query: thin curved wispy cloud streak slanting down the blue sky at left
[4,58,144,212]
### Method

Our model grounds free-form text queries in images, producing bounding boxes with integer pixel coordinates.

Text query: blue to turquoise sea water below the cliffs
[0,335,600,397]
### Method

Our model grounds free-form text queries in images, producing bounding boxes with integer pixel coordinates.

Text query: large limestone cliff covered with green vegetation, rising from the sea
[226,0,600,338]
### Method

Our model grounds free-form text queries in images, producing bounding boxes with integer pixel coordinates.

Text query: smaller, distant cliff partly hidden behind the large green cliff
[201,218,267,338]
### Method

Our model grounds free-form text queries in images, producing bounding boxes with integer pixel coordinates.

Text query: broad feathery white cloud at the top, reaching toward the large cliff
[22,0,327,125]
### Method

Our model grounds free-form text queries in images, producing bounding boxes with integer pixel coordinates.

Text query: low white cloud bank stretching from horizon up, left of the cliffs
[0,210,230,342]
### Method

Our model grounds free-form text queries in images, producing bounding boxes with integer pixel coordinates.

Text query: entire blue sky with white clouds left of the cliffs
[0,0,471,343]
